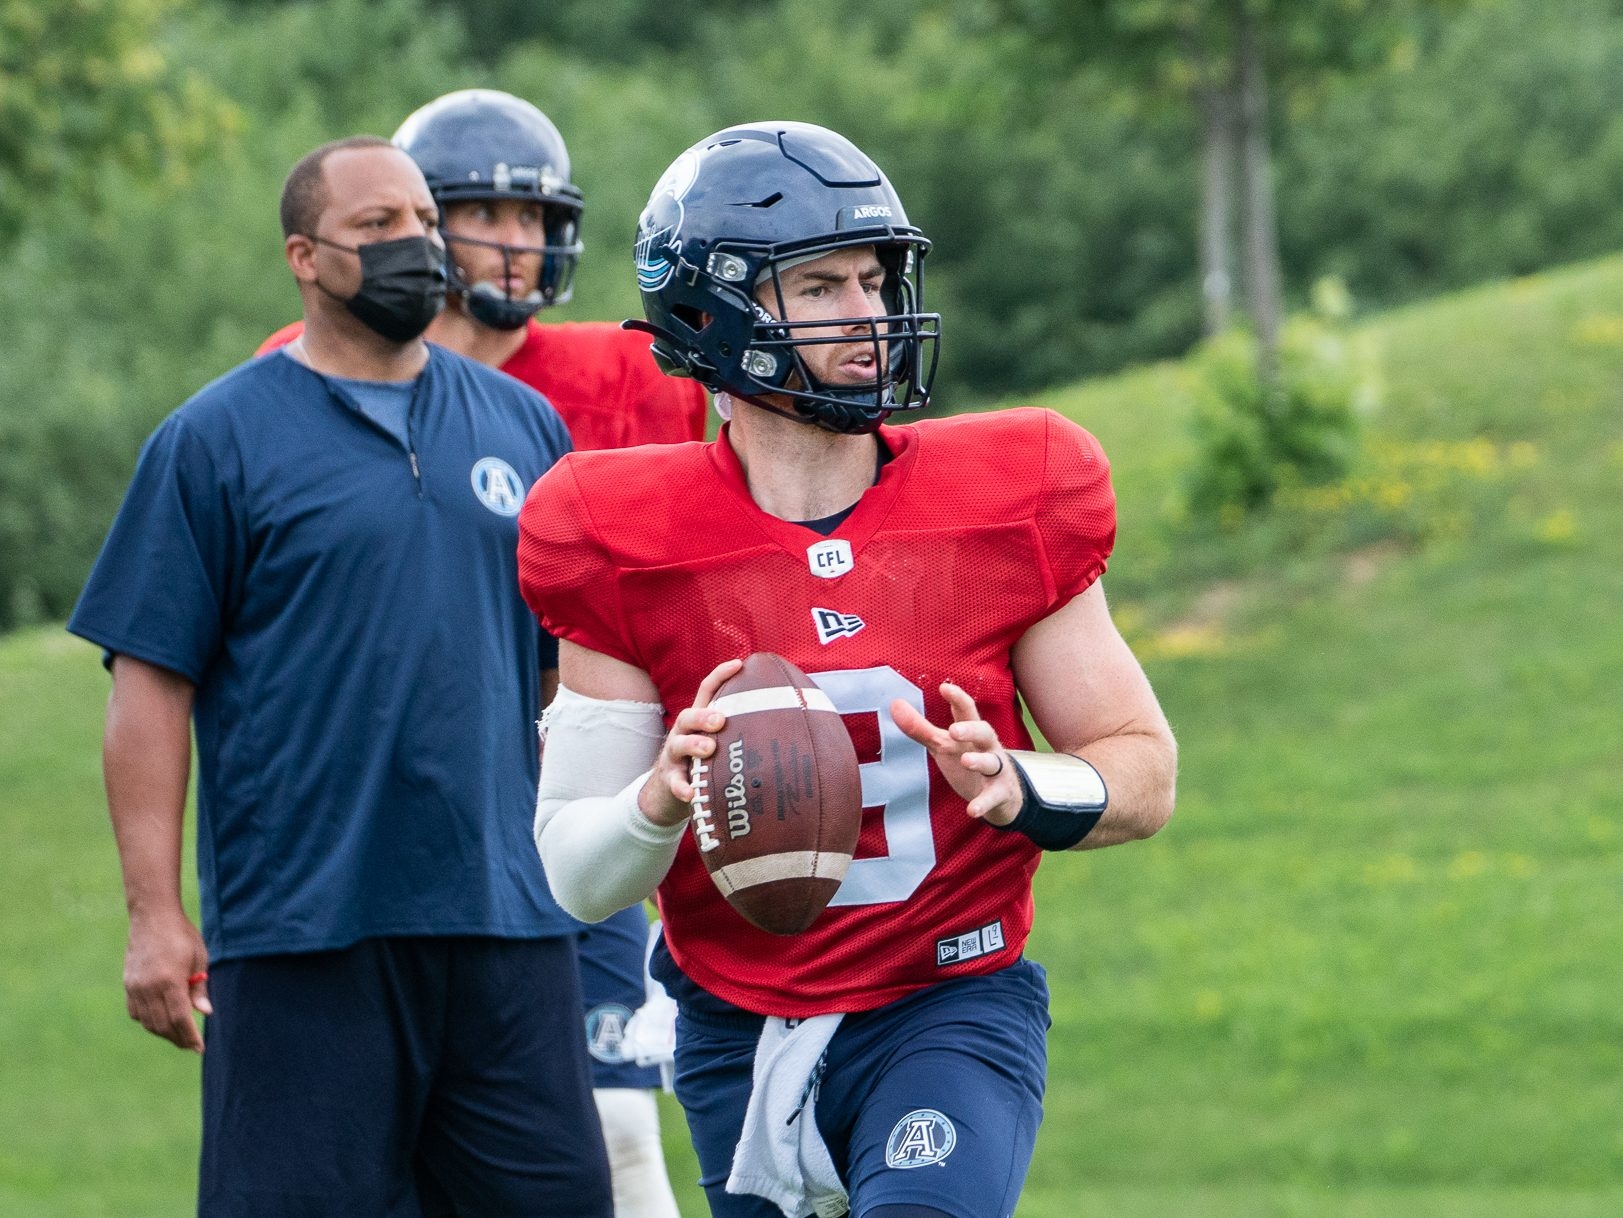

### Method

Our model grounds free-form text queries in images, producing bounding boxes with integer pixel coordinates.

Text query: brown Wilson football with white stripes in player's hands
[690,651,862,935]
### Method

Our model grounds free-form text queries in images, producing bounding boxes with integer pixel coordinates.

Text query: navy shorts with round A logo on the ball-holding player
[654,944,1048,1218]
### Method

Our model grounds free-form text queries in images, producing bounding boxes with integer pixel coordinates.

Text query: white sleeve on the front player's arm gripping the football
[536,687,687,922]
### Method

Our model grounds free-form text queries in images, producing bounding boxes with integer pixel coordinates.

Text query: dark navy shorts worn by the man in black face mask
[198,935,613,1218]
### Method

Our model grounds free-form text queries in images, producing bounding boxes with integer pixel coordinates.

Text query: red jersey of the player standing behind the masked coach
[253,318,709,450]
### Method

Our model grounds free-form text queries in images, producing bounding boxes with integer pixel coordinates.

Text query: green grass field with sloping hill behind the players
[0,260,1623,1218]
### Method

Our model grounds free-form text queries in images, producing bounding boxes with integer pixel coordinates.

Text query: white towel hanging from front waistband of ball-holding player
[727,1015,850,1218]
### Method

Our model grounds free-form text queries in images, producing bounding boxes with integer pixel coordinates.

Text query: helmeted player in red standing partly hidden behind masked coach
[260,89,708,1218]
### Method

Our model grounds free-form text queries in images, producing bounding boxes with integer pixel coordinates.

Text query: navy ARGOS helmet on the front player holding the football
[626,122,941,434]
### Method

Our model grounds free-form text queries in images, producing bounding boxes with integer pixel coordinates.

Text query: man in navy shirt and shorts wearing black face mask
[68,136,610,1216]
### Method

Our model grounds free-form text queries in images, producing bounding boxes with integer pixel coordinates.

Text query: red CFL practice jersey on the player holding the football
[519,409,1115,1018]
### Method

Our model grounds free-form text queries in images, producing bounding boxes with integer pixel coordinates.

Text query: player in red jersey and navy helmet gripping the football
[519,122,1175,1218]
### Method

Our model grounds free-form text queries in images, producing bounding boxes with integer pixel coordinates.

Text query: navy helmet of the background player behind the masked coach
[394,89,583,330]
